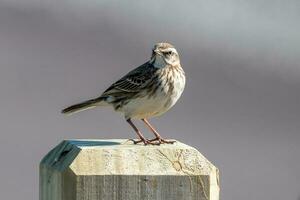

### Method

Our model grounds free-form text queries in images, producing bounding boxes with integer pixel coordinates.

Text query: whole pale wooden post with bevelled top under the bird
[40,139,219,200]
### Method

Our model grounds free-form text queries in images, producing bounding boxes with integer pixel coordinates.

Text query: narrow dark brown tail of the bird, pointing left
[61,98,102,114]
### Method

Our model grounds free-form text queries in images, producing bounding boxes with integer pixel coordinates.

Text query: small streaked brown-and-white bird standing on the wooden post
[62,42,186,145]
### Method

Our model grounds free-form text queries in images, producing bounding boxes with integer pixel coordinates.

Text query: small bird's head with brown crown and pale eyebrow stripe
[150,42,180,68]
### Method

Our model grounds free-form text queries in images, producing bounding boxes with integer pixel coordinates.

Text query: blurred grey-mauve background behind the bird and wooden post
[0,0,300,200]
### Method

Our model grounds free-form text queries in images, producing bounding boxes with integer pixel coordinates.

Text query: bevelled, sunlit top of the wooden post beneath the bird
[41,139,216,175]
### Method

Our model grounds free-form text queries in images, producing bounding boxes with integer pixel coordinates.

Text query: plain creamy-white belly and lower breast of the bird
[120,68,185,119]
